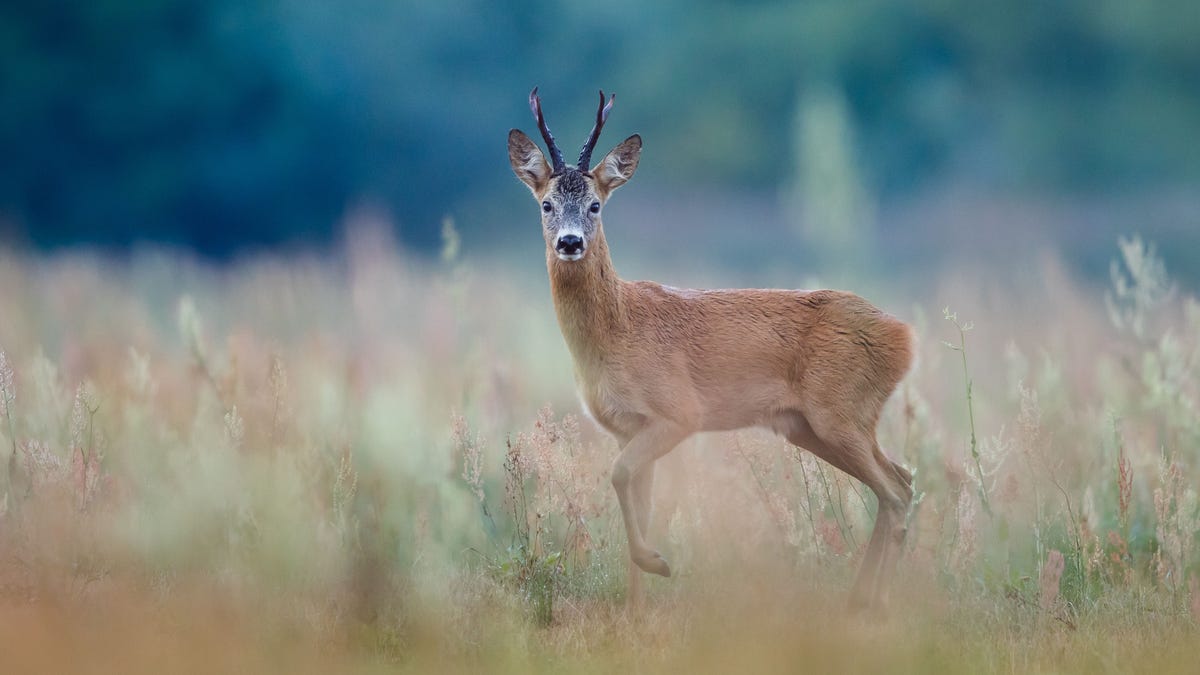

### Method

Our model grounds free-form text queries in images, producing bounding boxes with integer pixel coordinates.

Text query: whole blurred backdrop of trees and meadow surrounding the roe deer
[0,0,1200,674]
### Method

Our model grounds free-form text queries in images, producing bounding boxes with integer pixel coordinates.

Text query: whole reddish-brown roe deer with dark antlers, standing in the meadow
[509,88,914,608]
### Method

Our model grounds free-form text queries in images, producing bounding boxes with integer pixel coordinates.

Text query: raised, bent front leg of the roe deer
[612,423,689,577]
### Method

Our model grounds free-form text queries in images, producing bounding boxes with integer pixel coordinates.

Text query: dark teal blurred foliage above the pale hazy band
[0,0,1200,253]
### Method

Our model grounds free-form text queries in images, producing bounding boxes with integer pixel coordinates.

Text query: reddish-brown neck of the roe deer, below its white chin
[546,231,622,367]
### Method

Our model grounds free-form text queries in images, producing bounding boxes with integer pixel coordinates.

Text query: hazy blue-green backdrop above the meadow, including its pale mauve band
[0,0,1200,288]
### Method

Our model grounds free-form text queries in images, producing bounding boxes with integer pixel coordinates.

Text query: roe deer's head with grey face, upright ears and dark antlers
[509,86,642,262]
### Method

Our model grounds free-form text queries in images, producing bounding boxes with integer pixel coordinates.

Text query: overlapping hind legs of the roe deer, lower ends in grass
[785,413,912,609]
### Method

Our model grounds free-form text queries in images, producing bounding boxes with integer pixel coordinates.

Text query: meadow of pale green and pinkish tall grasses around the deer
[0,223,1200,673]
